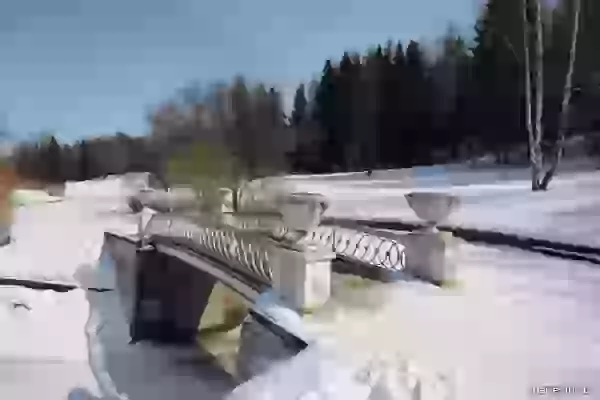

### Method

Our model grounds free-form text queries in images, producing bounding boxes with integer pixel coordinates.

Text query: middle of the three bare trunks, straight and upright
[532,0,544,190]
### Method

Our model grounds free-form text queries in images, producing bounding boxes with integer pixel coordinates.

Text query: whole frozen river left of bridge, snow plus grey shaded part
[0,178,233,400]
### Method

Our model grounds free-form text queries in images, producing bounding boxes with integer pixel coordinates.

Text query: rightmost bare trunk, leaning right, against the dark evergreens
[541,0,581,190]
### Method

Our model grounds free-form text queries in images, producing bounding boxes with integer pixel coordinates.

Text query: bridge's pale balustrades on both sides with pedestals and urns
[137,184,458,309]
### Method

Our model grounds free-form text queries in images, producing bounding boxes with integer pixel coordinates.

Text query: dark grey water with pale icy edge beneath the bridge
[85,268,234,400]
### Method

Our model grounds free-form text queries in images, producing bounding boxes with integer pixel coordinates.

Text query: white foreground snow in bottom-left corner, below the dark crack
[0,286,99,400]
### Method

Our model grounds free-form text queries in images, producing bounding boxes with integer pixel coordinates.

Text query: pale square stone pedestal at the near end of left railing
[269,243,335,312]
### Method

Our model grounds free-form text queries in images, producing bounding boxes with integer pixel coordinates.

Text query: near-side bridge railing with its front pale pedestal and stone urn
[141,194,335,310]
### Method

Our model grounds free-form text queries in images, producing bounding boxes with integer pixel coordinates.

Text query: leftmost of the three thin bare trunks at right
[522,0,541,190]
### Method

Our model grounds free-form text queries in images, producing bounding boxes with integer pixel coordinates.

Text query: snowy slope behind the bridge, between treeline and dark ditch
[289,167,600,247]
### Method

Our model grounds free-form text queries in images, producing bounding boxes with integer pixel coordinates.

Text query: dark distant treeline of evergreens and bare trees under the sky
[5,0,600,181]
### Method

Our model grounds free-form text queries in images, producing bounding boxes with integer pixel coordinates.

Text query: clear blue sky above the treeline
[0,0,477,141]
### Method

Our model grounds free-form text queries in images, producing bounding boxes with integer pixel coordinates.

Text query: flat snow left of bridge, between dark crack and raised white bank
[0,199,137,288]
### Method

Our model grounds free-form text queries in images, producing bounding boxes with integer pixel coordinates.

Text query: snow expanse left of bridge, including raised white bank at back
[0,178,138,289]
